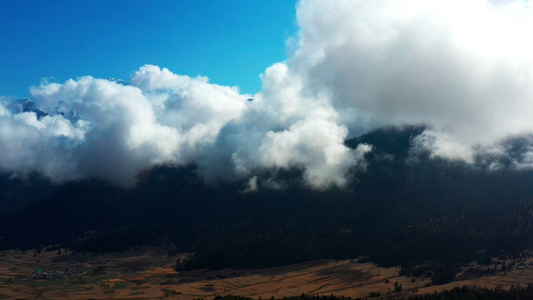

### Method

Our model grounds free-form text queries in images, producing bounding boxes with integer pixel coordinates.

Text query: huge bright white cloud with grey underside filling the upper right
[291,0,533,160]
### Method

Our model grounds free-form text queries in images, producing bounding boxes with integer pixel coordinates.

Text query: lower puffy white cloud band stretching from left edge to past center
[0,64,360,191]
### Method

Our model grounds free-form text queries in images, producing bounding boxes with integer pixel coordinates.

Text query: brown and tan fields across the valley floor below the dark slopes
[0,248,533,299]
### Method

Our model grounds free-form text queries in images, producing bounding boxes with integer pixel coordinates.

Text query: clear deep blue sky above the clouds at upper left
[0,0,297,98]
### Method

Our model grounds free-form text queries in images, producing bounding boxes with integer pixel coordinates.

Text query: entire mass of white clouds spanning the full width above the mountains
[0,0,533,191]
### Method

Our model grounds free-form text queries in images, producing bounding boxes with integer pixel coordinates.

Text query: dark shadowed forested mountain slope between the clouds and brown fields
[0,126,533,284]
